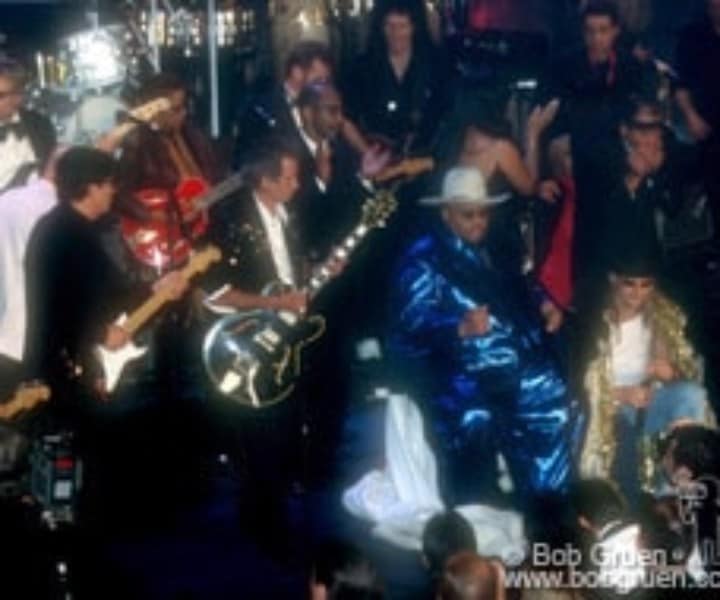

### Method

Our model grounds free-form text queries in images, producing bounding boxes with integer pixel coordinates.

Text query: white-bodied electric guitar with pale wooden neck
[95,246,222,392]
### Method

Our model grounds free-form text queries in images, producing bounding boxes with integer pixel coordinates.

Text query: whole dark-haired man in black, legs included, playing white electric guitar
[24,147,187,514]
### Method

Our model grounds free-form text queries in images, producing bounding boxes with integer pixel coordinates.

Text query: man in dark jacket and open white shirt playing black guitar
[202,140,308,551]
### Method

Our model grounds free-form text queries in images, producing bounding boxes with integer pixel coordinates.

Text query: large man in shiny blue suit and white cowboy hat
[387,167,571,505]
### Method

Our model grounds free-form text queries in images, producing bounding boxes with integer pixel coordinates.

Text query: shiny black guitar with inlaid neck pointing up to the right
[203,190,397,409]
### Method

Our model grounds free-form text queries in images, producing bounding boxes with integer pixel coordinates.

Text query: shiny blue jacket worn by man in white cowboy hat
[387,226,564,392]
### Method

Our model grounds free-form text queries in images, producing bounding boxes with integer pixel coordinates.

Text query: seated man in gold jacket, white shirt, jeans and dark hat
[578,247,711,503]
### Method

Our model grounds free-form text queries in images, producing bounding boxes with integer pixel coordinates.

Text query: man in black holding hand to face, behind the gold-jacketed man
[573,98,694,310]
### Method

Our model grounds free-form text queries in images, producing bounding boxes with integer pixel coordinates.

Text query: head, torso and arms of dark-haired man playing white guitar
[25,147,186,419]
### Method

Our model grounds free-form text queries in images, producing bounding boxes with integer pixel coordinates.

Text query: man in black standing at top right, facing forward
[549,1,653,303]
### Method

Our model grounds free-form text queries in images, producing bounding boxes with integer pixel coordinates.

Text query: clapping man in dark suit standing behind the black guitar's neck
[286,83,384,482]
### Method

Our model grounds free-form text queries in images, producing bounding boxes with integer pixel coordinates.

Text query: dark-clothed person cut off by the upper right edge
[676,0,720,237]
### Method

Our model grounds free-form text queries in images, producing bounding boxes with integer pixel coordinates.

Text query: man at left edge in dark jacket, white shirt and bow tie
[0,57,56,192]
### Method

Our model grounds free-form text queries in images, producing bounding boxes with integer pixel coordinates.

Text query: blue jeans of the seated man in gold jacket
[613,381,707,505]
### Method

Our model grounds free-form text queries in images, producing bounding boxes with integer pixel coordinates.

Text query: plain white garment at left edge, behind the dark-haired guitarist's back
[0,179,57,361]
